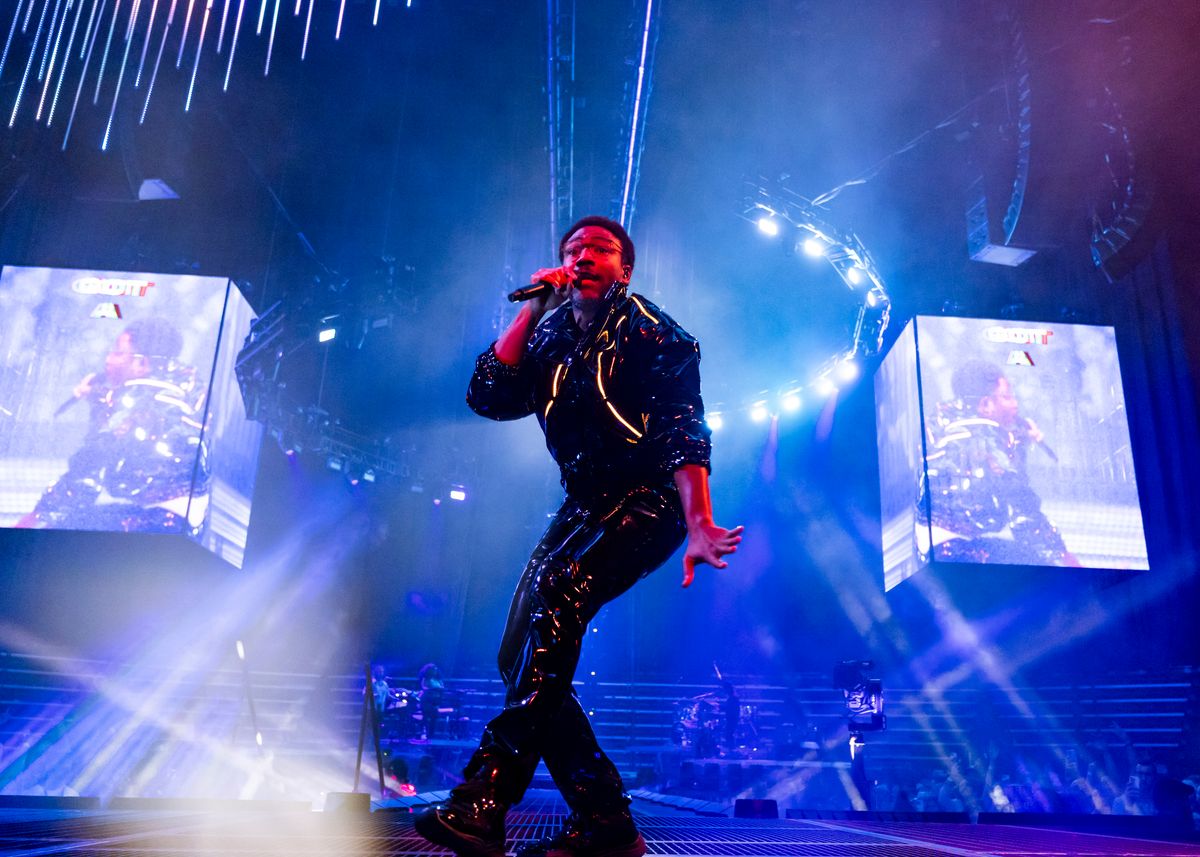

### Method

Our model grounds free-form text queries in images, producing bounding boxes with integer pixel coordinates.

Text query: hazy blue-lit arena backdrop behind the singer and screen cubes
[0,0,1200,696]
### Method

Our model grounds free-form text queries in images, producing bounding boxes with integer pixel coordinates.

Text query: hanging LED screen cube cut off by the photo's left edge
[0,266,262,568]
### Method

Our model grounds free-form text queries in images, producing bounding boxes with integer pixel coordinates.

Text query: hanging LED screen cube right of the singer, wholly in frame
[875,316,1148,589]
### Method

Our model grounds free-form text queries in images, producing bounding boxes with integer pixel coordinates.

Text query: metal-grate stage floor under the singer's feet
[0,793,1200,857]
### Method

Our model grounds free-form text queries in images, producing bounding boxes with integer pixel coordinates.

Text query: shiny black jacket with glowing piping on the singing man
[467,283,712,501]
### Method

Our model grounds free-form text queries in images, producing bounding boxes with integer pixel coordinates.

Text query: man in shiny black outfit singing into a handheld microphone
[416,216,742,857]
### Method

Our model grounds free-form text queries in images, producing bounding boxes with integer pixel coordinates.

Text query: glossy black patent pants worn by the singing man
[464,485,686,814]
